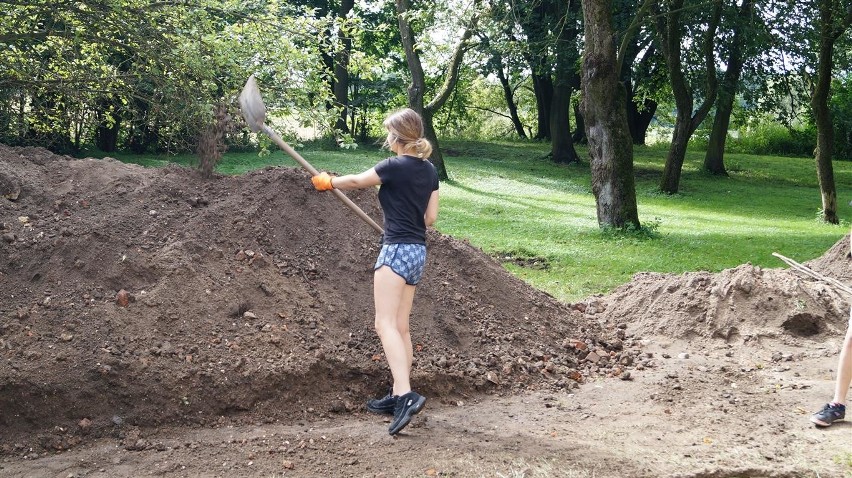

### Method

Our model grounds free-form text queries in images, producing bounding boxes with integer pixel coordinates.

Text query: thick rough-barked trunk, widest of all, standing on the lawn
[582,0,640,228]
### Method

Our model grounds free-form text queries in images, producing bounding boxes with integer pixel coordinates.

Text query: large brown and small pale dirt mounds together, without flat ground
[0,145,852,457]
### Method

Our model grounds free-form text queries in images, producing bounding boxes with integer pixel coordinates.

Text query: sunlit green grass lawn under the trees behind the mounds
[90,141,852,302]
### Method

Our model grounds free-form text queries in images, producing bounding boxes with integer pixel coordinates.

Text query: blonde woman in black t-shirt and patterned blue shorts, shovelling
[311,108,438,435]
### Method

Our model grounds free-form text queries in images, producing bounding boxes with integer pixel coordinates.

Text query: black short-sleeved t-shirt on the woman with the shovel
[375,156,438,244]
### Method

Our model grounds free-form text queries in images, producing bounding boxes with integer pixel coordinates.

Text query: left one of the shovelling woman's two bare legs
[373,266,411,395]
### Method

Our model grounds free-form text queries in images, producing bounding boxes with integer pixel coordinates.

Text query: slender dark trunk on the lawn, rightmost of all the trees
[811,0,852,224]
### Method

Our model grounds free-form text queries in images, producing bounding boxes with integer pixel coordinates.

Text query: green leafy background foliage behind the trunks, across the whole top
[0,0,852,173]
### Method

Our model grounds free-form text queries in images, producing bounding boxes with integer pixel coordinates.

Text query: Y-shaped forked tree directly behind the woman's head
[395,0,479,180]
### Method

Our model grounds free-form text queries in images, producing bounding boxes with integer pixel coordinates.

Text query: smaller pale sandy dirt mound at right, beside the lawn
[597,236,852,343]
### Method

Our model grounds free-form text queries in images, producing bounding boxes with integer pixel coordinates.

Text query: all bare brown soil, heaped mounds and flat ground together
[0,145,852,478]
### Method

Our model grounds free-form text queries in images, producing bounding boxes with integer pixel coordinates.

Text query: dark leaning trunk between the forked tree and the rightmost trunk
[704,0,753,176]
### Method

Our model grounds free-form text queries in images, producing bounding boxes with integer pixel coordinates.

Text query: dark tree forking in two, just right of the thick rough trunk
[656,0,722,194]
